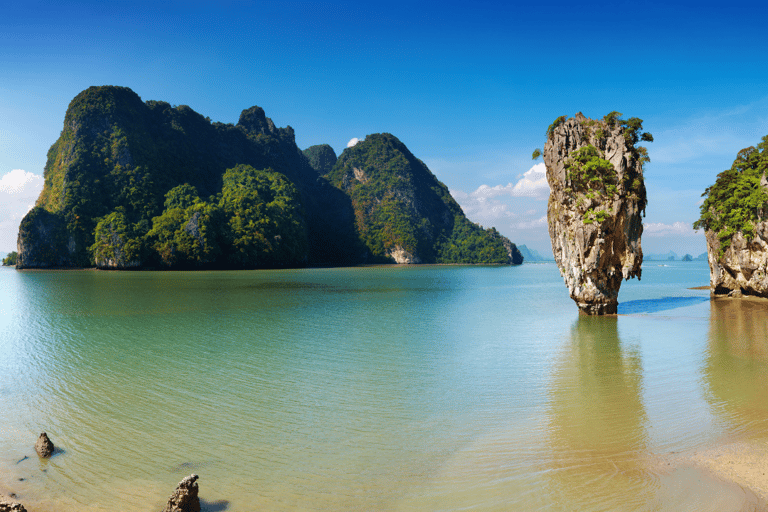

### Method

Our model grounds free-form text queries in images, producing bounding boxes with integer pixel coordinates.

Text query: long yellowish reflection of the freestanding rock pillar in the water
[545,316,649,510]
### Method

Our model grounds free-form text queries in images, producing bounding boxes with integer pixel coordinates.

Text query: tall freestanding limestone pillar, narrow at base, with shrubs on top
[544,112,653,315]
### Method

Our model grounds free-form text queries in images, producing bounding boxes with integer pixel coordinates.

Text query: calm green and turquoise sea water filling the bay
[0,262,768,512]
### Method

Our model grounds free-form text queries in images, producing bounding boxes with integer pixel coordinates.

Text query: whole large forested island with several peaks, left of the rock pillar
[16,86,523,269]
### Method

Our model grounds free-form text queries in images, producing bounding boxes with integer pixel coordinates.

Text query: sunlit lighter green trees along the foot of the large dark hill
[91,165,307,269]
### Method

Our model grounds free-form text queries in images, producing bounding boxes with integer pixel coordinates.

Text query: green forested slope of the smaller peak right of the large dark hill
[327,133,510,263]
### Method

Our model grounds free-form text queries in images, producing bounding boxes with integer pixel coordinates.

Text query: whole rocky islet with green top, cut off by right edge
[693,136,768,298]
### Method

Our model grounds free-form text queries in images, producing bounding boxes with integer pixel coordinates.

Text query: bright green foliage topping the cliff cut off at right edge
[693,135,768,256]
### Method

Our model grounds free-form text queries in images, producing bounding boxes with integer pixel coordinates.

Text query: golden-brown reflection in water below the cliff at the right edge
[703,299,768,437]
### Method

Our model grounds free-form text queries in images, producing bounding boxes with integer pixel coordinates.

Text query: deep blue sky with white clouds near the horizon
[0,0,768,255]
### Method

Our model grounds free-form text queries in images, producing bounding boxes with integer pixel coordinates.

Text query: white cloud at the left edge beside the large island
[0,169,44,252]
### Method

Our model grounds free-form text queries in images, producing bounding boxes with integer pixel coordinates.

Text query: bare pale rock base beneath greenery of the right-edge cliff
[706,221,768,297]
